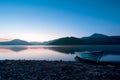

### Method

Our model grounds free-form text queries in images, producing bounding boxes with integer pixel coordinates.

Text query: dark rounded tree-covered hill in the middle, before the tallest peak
[47,37,84,45]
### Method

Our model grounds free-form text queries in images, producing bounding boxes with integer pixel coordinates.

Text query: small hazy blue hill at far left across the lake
[0,39,30,45]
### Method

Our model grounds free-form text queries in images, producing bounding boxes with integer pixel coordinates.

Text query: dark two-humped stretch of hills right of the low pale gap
[43,33,120,45]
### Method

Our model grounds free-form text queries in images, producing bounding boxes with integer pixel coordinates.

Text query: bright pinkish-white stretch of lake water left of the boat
[0,46,74,61]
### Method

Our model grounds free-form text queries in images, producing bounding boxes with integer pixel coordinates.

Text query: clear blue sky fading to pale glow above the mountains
[0,0,120,41]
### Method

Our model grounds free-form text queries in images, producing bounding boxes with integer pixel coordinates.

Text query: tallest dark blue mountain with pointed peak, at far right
[81,33,120,45]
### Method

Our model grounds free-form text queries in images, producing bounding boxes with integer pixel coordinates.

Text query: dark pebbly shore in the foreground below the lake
[0,60,120,80]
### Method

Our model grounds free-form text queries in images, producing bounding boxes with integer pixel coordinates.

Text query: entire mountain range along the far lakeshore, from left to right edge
[0,33,120,45]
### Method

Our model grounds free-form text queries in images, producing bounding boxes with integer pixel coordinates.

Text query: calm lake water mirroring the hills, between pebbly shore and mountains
[0,45,120,61]
